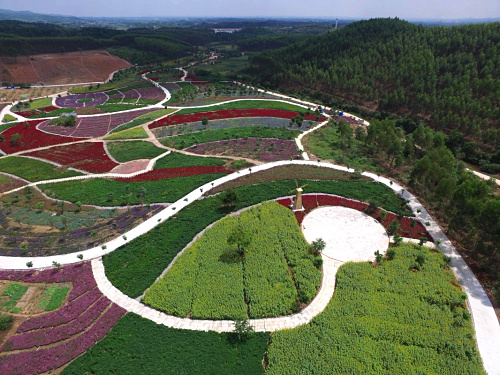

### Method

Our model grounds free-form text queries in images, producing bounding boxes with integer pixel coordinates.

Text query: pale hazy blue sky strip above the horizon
[0,0,500,19]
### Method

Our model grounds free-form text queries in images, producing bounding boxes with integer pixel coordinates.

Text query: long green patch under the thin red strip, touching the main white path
[42,173,226,206]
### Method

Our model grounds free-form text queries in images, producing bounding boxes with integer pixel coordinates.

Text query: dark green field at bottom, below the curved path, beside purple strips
[62,313,269,375]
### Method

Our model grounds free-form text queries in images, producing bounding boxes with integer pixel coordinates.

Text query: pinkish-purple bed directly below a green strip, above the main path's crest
[185,138,300,162]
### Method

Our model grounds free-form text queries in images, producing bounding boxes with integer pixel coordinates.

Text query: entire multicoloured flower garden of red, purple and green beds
[0,76,484,375]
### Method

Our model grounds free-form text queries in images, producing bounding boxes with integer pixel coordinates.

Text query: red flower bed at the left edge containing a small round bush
[0,120,78,154]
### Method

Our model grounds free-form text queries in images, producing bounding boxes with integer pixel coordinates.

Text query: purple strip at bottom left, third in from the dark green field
[16,288,102,333]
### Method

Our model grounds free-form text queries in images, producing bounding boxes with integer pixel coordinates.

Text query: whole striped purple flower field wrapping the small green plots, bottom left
[0,262,125,375]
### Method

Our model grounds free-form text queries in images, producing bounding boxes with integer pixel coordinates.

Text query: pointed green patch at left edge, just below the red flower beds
[0,156,82,182]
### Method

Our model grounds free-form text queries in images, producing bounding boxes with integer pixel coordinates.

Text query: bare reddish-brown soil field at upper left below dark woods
[0,50,132,85]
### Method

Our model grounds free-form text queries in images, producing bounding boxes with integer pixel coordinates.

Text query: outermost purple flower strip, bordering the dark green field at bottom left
[0,304,126,375]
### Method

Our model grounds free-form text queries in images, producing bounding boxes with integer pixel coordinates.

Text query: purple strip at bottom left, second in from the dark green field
[0,296,111,351]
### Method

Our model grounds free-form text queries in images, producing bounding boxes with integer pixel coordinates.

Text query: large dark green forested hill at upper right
[253,19,500,153]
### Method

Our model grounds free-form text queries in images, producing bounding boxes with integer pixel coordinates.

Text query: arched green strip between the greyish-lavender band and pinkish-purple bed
[160,126,300,149]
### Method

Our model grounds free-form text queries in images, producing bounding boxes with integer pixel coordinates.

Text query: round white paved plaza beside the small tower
[302,207,389,262]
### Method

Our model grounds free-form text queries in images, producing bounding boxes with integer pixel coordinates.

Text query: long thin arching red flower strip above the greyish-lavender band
[149,108,324,129]
